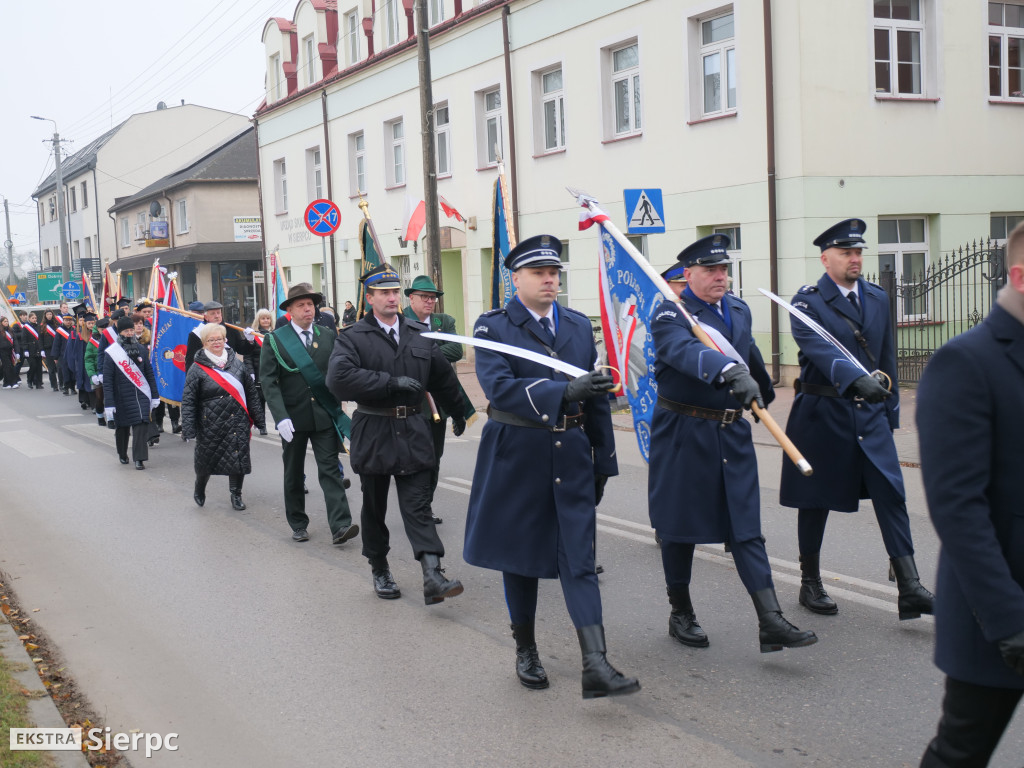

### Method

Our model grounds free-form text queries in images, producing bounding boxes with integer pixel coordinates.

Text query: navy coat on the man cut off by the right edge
[918,306,1024,688]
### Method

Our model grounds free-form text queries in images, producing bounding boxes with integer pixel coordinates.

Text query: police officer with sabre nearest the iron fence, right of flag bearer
[779,219,933,620]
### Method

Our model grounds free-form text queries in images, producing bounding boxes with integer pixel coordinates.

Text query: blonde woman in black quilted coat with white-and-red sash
[181,323,266,510]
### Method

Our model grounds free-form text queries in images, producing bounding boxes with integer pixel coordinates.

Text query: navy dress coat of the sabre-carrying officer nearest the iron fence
[779,274,906,512]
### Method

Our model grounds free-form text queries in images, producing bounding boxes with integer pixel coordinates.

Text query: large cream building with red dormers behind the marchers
[255,0,1024,367]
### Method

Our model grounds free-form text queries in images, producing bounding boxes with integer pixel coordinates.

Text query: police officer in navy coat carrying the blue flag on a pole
[647,234,817,653]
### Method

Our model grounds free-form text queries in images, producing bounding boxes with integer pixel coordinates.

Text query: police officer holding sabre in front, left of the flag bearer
[463,234,640,698]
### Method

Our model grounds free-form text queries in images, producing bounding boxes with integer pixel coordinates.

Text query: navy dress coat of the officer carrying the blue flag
[647,293,775,544]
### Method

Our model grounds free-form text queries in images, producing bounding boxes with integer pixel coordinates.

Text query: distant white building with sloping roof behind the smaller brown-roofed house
[32,104,249,301]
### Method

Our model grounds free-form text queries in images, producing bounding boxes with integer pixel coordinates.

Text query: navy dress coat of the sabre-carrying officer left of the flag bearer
[463,300,618,579]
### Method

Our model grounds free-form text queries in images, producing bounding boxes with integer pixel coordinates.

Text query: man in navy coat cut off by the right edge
[918,219,1024,768]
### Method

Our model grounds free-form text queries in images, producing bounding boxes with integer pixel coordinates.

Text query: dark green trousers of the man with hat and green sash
[281,427,352,534]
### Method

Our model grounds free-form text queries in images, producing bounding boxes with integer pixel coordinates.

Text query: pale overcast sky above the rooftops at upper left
[0,0,298,259]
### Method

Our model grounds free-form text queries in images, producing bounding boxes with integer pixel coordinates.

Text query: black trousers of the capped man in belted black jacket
[359,469,444,564]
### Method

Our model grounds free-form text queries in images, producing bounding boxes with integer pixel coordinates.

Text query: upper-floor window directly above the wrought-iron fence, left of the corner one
[874,0,925,96]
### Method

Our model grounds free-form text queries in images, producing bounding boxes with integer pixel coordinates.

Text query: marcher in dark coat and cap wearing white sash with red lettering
[103,317,160,469]
